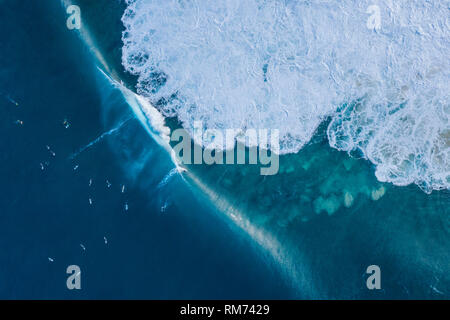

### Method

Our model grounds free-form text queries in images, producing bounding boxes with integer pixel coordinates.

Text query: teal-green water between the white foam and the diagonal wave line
[75,2,450,298]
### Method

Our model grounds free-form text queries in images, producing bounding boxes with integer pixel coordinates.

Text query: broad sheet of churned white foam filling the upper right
[122,0,450,192]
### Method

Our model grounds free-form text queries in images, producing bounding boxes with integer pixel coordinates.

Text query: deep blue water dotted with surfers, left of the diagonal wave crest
[0,0,292,299]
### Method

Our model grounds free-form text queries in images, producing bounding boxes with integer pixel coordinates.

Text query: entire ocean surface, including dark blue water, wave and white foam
[0,0,450,299]
